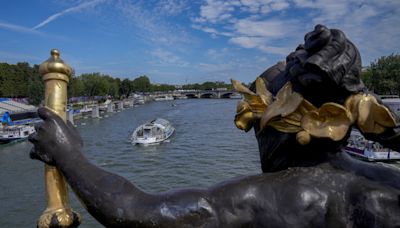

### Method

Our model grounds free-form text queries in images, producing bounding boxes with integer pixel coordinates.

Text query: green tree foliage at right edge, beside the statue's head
[361,54,400,95]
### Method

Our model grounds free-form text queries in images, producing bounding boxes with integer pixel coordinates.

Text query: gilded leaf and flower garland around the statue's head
[232,78,396,145]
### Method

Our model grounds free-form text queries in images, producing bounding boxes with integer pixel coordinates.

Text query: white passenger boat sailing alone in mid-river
[131,118,175,145]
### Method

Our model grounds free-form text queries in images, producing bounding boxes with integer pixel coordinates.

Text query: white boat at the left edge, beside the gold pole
[0,125,35,144]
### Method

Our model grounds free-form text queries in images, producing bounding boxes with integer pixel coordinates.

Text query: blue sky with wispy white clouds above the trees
[0,0,400,84]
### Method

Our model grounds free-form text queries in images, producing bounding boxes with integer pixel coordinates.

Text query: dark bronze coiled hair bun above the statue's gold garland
[285,25,366,107]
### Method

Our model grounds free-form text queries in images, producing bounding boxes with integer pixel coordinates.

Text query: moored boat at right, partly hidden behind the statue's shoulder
[344,130,400,161]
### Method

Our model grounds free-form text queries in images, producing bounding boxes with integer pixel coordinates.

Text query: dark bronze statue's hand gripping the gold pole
[29,108,83,165]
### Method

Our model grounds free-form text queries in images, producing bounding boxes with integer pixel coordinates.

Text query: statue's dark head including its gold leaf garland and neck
[233,25,394,171]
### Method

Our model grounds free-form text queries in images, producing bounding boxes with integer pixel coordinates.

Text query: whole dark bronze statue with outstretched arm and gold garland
[30,25,400,227]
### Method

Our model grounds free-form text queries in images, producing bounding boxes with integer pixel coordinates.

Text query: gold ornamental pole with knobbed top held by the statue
[37,49,81,228]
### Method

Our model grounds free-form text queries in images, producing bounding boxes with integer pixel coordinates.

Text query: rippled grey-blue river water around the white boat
[0,99,261,227]
